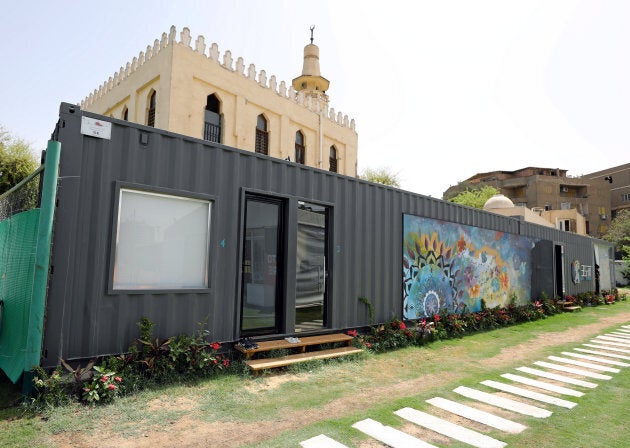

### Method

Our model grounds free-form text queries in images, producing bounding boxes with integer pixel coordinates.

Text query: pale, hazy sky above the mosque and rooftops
[0,0,630,198]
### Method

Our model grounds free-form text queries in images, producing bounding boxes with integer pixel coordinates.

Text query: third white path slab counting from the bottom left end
[394,408,507,448]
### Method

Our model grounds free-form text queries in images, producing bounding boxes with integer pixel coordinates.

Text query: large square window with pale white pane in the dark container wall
[113,188,211,290]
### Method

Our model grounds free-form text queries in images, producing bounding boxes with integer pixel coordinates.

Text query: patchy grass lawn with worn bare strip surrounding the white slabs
[0,301,630,448]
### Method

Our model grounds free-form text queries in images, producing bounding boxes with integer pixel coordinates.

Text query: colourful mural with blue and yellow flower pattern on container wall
[403,215,537,319]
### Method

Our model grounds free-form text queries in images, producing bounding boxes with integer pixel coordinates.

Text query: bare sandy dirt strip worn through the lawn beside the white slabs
[53,313,630,448]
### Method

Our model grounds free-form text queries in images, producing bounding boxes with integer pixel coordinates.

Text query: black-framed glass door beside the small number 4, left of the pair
[241,196,283,335]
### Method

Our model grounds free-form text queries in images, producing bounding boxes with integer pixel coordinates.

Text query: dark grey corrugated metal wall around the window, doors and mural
[43,104,616,365]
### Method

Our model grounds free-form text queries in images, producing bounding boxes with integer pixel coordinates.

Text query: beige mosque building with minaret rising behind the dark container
[81,26,358,176]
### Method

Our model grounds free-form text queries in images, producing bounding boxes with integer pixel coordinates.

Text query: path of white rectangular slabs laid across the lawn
[300,325,630,448]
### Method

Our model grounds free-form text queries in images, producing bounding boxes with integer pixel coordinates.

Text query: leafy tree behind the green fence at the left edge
[0,126,39,194]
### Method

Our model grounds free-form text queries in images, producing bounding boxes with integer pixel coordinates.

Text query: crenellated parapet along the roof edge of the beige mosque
[80,26,356,131]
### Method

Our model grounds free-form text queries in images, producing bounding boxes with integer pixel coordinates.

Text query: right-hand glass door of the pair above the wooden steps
[295,202,328,332]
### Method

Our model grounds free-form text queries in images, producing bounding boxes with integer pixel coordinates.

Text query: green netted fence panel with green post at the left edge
[0,141,61,389]
